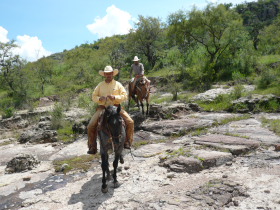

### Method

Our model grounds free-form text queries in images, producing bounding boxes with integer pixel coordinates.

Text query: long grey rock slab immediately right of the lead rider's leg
[142,117,214,136]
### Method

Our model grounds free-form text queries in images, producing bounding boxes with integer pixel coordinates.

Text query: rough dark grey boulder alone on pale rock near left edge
[5,154,40,174]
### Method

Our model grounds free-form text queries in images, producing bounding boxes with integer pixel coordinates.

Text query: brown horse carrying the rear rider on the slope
[128,77,150,115]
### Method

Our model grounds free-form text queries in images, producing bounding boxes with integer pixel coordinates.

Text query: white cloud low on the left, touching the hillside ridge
[14,35,51,61]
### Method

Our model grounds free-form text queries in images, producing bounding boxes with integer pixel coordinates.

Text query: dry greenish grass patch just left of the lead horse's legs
[53,154,100,174]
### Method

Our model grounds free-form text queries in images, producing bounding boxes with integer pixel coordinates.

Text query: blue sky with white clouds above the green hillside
[0,0,254,61]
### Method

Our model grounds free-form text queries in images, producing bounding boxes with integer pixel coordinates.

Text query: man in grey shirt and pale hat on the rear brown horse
[130,56,150,98]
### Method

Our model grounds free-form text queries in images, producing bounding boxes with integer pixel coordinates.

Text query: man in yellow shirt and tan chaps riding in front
[87,66,134,154]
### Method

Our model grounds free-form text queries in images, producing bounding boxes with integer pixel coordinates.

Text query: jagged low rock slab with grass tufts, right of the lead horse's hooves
[159,150,233,173]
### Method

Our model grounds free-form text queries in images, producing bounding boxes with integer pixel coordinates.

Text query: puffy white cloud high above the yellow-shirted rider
[86,5,132,38]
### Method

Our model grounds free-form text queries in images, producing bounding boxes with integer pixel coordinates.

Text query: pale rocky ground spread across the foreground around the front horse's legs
[0,86,280,210]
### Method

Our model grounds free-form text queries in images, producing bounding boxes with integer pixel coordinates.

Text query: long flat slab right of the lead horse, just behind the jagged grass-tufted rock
[194,134,260,155]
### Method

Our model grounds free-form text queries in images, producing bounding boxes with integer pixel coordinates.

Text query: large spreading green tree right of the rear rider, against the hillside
[168,4,254,82]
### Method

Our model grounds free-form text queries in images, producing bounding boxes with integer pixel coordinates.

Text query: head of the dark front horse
[104,105,122,143]
